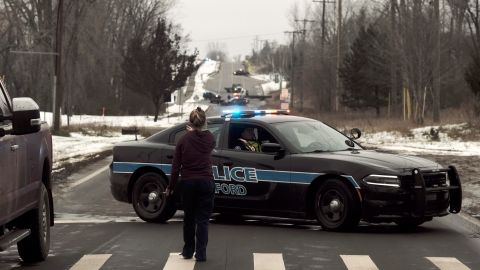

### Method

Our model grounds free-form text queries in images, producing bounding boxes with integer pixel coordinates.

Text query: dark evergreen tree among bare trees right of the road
[340,25,390,116]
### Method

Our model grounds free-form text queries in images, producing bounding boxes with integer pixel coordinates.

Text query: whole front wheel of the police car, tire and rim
[315,179,360,231]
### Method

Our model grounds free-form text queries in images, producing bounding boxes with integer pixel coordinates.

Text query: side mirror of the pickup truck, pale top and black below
[12,97,42,135]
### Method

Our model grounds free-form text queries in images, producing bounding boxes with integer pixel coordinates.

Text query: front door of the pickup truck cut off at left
[0,85,18,224]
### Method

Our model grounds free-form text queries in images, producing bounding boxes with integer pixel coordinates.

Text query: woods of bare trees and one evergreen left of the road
[0,0,197,127]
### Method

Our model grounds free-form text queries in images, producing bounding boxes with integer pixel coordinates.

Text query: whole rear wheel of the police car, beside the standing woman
[132,172,177,223]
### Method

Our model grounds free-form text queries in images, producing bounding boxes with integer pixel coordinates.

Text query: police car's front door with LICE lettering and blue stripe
[213,119,291,212]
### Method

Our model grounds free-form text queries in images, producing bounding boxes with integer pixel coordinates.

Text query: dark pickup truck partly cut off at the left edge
[0,81,54,263]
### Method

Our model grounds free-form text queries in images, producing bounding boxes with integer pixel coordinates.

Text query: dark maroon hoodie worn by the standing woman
[169,130,215,190]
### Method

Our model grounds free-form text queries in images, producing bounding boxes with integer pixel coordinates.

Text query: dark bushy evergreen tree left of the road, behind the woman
[122,19,198,122]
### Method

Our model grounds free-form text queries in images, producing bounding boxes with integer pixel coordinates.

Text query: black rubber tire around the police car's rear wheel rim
[132,172,176,223]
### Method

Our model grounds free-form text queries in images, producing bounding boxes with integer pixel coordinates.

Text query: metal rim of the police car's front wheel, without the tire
[317,189,346,225]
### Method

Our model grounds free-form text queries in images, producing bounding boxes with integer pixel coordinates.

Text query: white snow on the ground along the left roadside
[47,59,218,172]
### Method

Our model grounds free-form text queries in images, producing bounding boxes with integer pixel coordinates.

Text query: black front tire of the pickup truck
[17,183,50,263]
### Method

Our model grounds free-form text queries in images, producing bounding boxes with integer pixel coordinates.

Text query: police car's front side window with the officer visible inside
[228,123,278,152]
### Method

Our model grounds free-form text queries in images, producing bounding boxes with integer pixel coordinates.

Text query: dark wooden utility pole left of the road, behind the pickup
[53,0,63,133]
